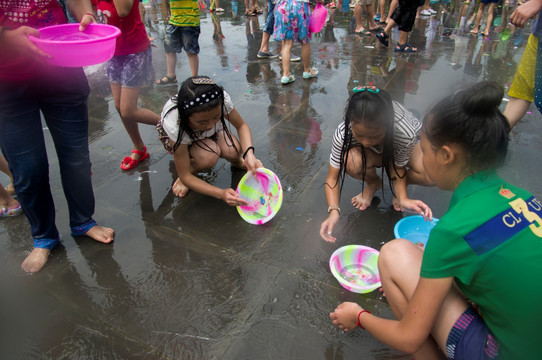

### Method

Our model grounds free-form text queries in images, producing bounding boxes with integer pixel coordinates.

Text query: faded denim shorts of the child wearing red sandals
[107,46,152,88]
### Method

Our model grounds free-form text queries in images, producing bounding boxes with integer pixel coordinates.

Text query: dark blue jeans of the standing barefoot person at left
[0,67,96,249]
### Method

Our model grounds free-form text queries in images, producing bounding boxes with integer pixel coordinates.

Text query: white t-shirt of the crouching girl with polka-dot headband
[160,91,233,145]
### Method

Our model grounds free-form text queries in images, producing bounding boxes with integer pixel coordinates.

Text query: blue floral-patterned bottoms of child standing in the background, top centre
[273,0,311,44]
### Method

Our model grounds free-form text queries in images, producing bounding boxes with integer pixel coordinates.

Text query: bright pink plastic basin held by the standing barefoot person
[29,24,120,67]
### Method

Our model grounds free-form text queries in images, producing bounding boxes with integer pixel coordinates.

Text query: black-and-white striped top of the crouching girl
[329,101,422,169]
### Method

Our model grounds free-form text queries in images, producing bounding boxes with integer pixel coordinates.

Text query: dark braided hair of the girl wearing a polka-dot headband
[166,75,239,153]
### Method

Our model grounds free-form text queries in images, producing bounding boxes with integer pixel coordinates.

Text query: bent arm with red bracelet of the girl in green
[329,277,453,354]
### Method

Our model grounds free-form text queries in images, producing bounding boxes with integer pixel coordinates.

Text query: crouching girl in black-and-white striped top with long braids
[320,86,432,242]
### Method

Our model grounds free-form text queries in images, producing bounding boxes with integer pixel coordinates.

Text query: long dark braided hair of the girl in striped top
[334,89,406,198]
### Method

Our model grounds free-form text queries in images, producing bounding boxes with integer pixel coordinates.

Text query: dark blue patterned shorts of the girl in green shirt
[446,307,499,360]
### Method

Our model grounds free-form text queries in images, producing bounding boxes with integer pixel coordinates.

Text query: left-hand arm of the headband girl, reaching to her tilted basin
[173,144,248,206]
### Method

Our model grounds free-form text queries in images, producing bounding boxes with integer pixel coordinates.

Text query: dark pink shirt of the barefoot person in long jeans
[0,0,66,81]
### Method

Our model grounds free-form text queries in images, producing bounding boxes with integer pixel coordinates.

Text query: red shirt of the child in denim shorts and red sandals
[97,0,150,55]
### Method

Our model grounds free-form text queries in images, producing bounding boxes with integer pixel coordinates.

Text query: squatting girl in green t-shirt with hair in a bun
[330,82,542,360]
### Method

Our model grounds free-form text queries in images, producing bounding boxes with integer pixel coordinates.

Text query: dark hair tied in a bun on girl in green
[423,81,510,173]
